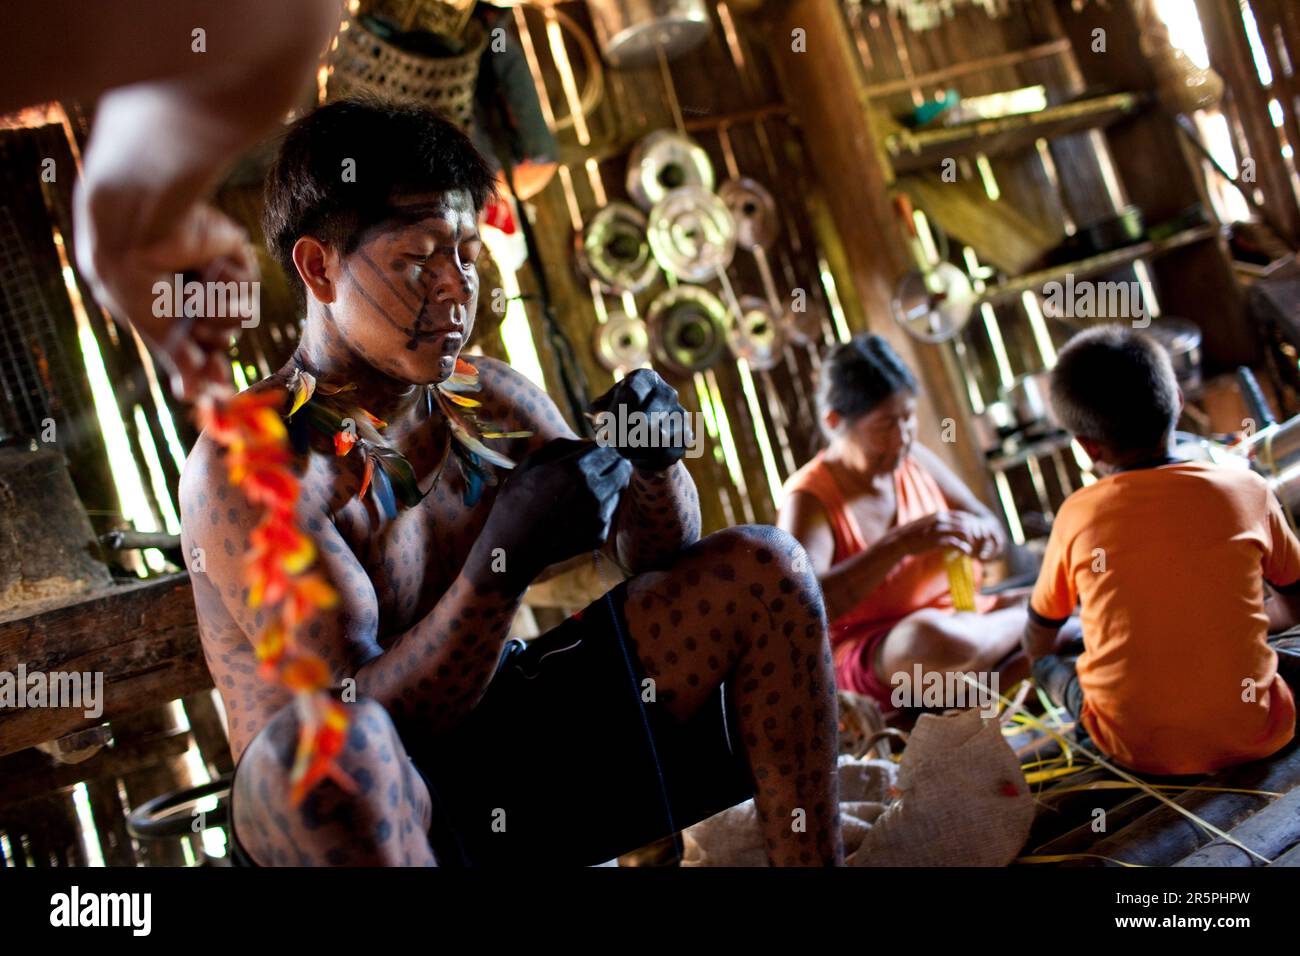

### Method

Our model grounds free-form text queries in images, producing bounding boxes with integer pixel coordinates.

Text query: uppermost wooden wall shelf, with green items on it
[884,92,1144,176]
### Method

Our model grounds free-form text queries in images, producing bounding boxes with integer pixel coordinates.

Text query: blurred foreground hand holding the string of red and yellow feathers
[75,186,260,401]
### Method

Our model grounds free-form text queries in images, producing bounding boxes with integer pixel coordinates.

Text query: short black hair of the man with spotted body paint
[263,96,495,278]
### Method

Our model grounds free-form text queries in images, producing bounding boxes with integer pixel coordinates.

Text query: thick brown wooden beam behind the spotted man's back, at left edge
[0,572,212,754]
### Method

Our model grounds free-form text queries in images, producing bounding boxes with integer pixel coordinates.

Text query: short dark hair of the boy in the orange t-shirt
[1052,325,1179,454]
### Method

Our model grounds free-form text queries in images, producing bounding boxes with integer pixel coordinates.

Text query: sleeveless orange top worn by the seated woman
[785,451,997,657]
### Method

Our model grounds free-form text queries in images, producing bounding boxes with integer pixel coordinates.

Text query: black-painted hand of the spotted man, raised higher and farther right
[592,368,692,472]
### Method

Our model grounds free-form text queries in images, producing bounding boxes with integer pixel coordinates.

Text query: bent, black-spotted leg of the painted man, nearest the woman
[625,525,844,866]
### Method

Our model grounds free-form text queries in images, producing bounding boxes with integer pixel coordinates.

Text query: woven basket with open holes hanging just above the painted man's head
[328,20,488,129]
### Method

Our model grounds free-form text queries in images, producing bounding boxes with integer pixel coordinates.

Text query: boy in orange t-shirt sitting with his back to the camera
[1024,325,1300,774]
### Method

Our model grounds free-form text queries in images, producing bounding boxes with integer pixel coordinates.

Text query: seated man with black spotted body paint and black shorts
[181,100,842,865]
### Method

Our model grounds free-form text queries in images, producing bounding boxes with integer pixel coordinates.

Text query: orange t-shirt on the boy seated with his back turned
[1030,462,1300,774]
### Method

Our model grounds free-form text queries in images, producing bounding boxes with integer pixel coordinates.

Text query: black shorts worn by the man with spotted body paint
[231,583,753,866]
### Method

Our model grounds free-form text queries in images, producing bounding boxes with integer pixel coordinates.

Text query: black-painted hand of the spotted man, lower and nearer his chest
[481,438,632,587]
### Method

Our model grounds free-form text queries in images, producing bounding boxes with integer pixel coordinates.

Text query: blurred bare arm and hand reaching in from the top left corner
[0,0,342,397]
